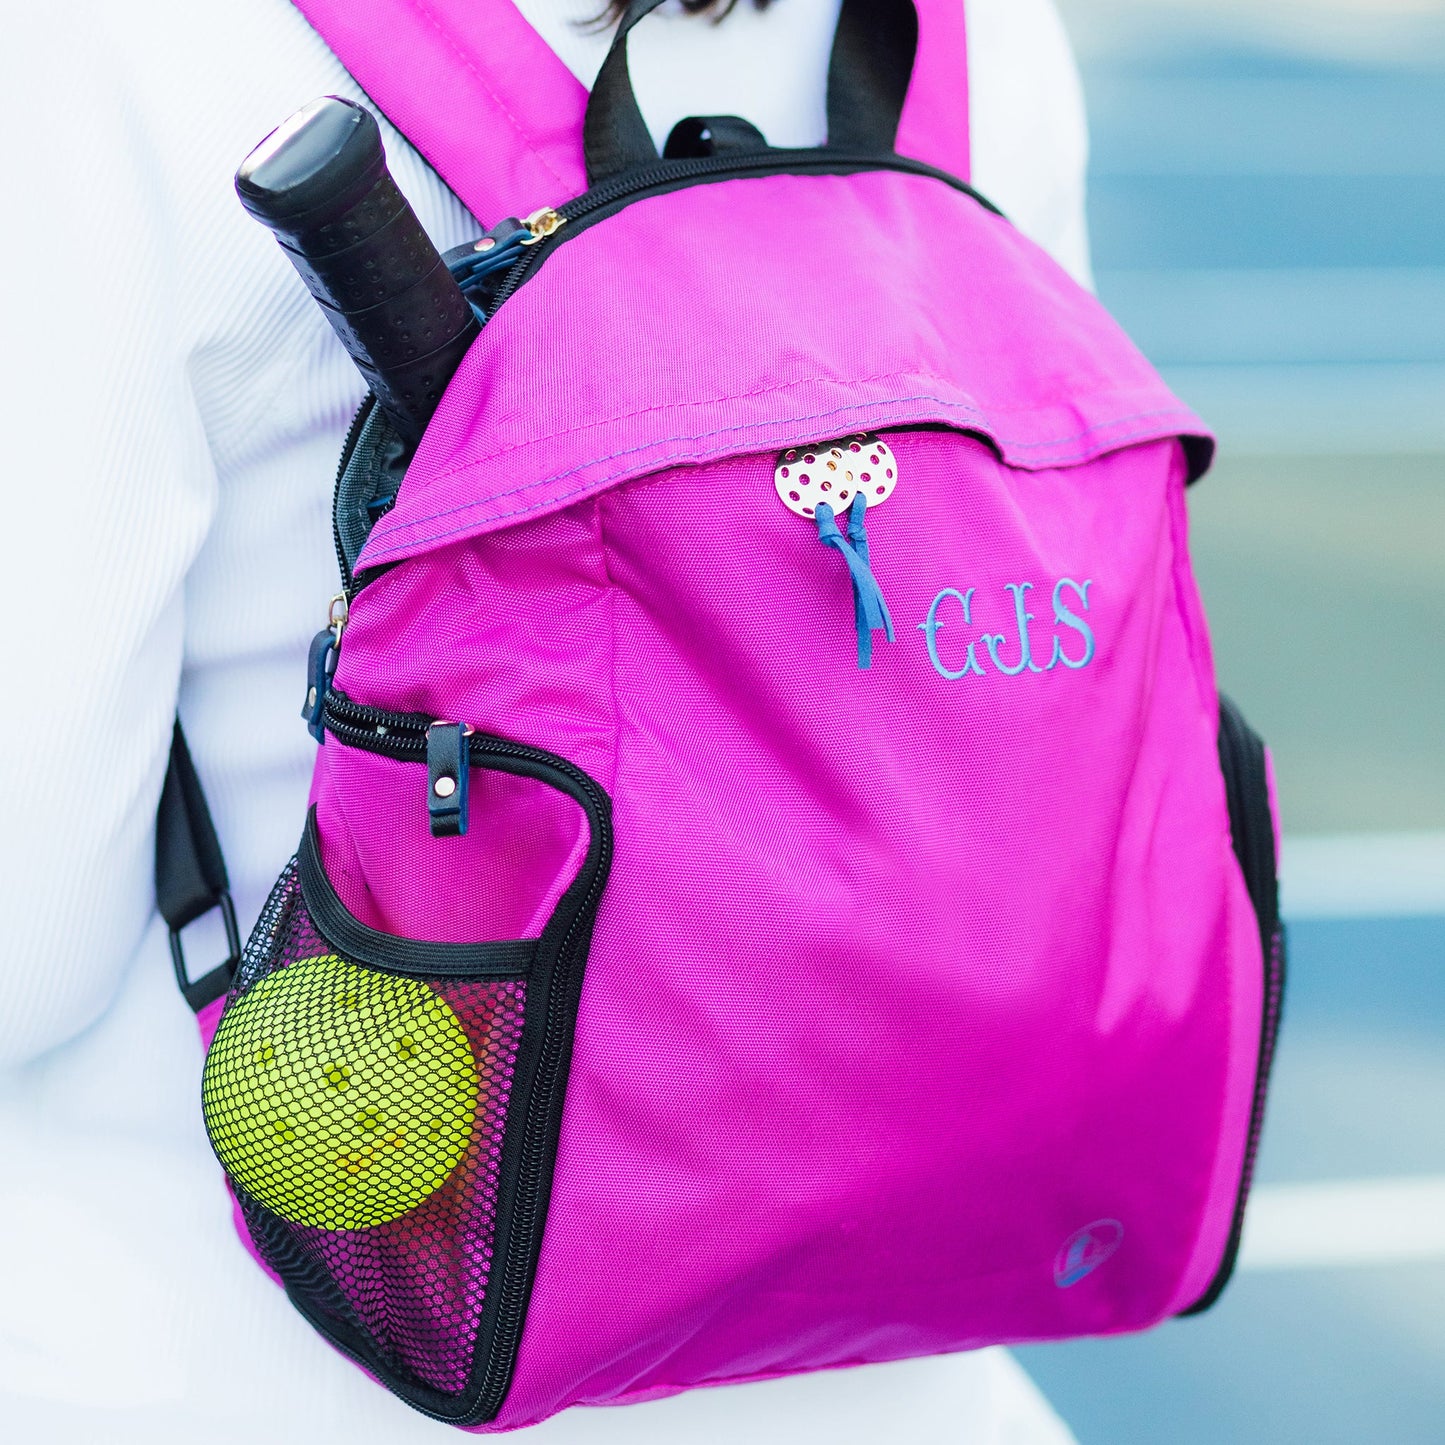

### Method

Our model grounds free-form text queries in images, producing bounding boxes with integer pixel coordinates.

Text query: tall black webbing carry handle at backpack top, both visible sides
[582,0,918,186]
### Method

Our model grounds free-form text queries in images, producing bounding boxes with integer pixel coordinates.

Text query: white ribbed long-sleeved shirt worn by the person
[0,0,1088,1445]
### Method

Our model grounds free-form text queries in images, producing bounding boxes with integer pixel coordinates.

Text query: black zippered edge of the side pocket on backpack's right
[1181,696,1285,1315]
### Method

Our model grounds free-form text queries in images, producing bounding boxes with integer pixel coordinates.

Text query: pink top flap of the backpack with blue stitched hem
[363,172,1204,565]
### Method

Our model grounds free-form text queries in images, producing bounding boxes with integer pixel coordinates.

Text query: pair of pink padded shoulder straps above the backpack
[295,0,968,225]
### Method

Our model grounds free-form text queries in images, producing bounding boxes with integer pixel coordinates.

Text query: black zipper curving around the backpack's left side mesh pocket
[312,689,613,1426]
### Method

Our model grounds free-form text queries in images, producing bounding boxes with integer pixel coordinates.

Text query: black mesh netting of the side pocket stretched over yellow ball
[202,863,526,1393]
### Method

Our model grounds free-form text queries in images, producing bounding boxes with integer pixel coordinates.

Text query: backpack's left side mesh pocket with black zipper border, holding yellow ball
[202,716,611,1423]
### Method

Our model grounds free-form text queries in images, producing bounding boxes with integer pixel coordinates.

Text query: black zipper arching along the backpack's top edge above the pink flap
[487,147,1003,319]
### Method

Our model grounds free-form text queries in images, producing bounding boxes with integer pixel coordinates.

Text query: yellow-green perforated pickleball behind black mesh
[201,954,478,1230]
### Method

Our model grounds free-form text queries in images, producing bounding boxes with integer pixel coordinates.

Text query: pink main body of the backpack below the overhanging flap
[321,432,1260,1426]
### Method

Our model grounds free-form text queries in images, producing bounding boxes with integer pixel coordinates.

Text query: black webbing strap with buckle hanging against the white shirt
[156,718,241,1013]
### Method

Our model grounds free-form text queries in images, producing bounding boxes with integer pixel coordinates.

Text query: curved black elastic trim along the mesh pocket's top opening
[296,803,538,978]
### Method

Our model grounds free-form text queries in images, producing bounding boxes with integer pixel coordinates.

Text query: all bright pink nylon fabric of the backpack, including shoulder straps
[222,0,1263,1429]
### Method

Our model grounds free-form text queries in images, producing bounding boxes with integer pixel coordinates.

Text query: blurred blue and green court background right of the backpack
[1020,0,1445,1445]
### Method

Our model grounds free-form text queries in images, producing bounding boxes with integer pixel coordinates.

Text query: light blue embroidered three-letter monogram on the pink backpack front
[918,577,1095,682]
